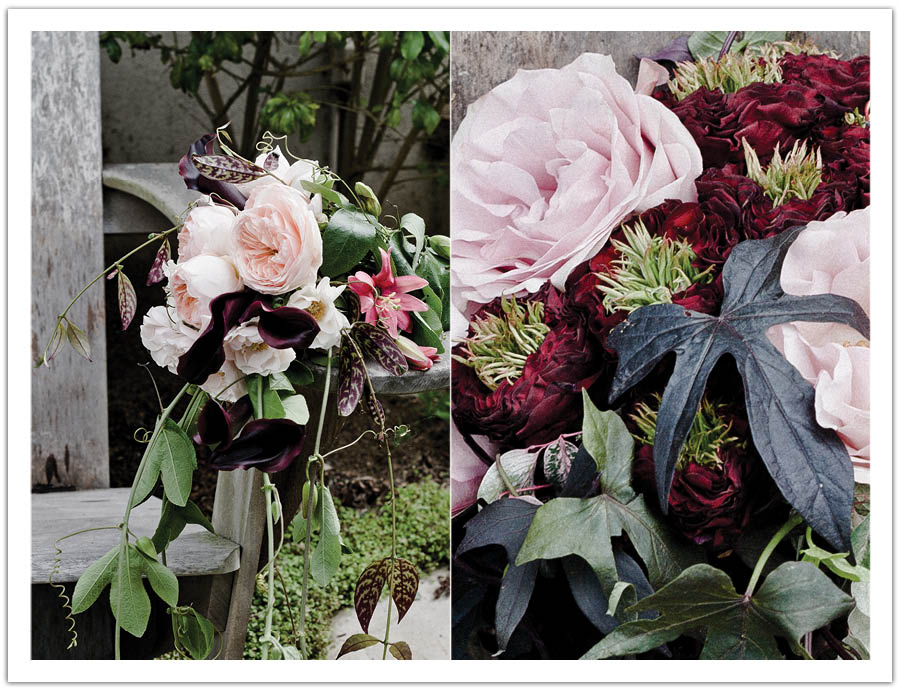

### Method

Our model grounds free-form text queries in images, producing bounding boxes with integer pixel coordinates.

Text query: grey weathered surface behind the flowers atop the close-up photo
[451,31,869,132]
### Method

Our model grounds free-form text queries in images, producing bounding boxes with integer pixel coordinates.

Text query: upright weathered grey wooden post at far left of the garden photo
[31,31,109,489]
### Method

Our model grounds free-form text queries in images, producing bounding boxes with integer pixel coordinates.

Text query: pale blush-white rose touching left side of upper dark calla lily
[163,254,243,329]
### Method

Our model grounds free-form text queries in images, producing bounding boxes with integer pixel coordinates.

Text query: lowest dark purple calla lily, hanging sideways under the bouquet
[209,418,306,473]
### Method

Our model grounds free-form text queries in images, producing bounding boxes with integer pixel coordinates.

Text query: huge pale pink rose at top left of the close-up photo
[450,53,703,316]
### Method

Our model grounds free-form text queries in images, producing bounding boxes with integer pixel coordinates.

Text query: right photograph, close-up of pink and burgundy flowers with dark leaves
[450,31,872,660]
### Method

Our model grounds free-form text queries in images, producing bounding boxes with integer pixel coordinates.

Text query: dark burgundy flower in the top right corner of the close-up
[779,55,869,111]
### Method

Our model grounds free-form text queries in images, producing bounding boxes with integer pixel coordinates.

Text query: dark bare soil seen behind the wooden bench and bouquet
[106,236,450,513]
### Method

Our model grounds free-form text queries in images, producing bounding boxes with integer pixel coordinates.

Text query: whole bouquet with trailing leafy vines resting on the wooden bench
[42,128,449,659]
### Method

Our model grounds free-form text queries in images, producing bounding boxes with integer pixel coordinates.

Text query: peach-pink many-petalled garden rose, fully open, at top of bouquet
[232,184,322,295]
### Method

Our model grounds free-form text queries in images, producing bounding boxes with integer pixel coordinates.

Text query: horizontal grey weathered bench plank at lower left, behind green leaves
[31,488,240,584]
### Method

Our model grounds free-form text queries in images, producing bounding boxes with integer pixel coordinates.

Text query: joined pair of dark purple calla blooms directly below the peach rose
[178,290,319,384]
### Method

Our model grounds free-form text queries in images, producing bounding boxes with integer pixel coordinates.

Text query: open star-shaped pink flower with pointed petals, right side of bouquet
[347,248,428,338]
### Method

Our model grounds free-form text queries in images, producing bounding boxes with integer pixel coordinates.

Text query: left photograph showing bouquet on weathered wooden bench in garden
[31,27,450,660]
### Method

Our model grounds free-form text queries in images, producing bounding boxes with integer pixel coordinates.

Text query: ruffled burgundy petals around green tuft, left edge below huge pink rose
[452,283,602,449]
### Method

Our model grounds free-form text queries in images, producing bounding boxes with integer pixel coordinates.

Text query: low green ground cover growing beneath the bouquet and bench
[244,480,450,660]
